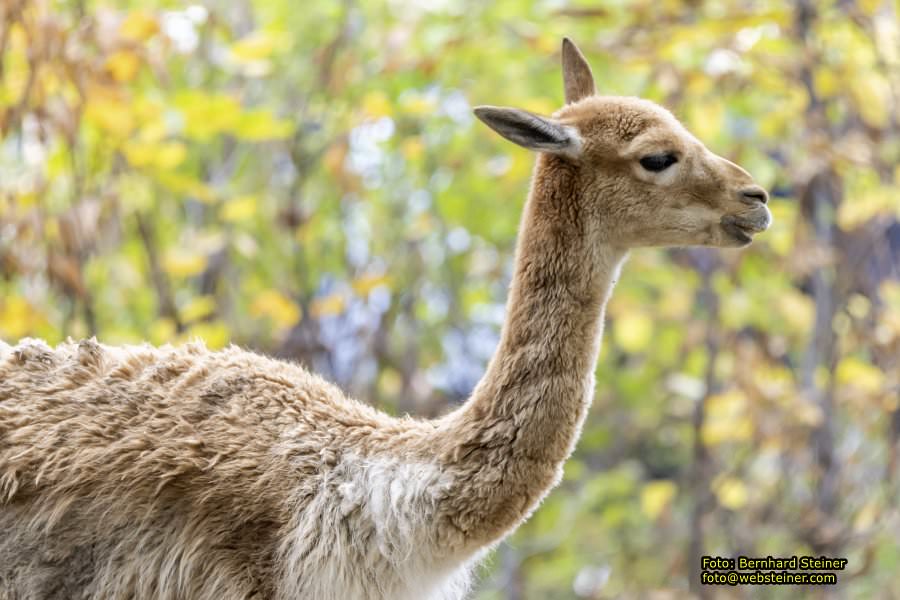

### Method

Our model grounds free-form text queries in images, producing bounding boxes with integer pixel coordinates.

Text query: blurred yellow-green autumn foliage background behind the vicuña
[0,0,900,600]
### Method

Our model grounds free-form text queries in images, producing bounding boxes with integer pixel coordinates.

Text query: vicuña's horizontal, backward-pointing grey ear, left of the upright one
[475,106,581,155]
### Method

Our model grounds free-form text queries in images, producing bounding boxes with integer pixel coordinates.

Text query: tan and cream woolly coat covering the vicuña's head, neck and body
[0,42,769,600]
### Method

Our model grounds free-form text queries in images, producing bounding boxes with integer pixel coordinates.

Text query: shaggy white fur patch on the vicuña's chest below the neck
[278,455,469,600]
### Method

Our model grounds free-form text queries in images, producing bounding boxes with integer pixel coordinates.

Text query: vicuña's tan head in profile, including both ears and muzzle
[475,38,772,248]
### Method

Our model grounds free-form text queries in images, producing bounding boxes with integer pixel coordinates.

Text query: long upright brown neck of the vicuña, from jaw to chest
[442,155,625,535]
